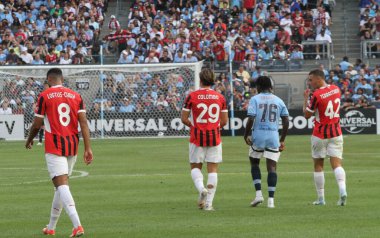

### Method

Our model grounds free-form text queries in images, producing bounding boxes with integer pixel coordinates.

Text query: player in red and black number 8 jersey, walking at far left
[25,68,93,237]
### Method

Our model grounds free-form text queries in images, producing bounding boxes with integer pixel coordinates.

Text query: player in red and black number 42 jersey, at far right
[303,69,347,206]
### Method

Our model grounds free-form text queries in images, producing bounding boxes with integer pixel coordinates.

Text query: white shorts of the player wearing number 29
[189,143,222,164]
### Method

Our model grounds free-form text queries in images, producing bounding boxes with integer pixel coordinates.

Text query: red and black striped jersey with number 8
[35,85,86,156]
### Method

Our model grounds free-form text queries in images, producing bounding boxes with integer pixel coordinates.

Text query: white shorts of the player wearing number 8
[45,153,77,179]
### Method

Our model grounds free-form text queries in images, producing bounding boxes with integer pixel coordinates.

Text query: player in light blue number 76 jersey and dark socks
[244,76,289,208]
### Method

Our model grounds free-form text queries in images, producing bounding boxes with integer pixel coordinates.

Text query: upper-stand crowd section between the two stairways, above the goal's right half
[110,0,331,64]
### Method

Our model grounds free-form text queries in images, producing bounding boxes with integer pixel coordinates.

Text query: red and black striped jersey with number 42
[306,85,342,139]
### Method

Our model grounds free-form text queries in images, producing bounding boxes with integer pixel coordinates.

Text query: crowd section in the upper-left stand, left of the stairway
[0,0,108,65]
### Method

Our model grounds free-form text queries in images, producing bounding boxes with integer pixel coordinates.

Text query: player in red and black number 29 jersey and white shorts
[181,68,228,211]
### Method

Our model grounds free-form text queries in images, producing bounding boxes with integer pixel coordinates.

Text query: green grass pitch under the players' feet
[0,135,380,238]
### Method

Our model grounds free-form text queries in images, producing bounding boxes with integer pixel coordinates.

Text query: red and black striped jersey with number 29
[182,88,227,146]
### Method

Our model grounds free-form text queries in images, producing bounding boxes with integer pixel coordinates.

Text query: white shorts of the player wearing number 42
[311,135,343,159]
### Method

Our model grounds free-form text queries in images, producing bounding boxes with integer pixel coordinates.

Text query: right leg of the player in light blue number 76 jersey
[263,148,281,208]
